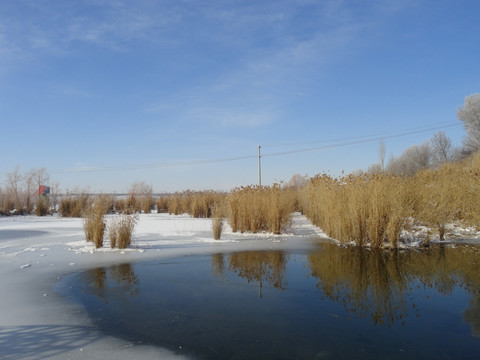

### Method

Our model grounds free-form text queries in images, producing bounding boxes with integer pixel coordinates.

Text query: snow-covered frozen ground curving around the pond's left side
[0,214,328,360]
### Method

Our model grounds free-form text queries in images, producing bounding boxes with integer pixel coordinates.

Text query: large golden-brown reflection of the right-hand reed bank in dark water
[308,245,480,326]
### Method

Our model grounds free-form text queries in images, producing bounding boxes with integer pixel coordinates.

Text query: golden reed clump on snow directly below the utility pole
[228,184,296,234]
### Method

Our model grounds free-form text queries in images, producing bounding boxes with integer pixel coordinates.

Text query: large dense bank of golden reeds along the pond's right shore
[300,152,480,248]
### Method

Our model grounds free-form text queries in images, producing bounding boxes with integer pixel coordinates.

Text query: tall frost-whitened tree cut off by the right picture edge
[457,94,480,153]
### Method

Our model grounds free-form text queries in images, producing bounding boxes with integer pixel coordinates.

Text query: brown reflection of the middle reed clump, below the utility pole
[228,251,287,289]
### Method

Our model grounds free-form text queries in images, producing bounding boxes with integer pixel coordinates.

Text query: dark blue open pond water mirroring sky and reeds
[67,245,480,359]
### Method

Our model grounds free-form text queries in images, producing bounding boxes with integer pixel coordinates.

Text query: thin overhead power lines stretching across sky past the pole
[51,122,461,174]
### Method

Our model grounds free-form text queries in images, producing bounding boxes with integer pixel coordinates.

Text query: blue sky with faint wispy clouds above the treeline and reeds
[0,0,480,192]
